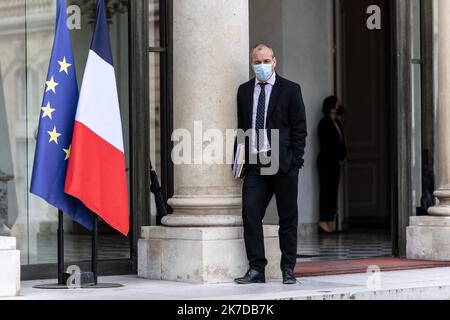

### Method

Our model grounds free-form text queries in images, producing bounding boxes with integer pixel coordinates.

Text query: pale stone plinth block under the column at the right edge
[406,216,450,261]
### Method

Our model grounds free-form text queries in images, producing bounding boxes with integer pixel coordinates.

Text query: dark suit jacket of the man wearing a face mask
[237,74,307,174]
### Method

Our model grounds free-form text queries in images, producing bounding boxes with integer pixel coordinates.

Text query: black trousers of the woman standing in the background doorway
[317,161,341,222]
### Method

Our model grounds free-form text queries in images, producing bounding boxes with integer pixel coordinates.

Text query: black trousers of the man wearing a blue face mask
[242,165,299,272]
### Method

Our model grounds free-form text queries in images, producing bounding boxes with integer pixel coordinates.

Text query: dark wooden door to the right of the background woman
[336,0,395,235]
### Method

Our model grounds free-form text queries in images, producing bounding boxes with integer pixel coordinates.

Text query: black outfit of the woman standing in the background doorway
[317,116,347,221]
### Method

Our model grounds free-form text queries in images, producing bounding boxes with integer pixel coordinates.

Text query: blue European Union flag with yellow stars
[31,0,92,230]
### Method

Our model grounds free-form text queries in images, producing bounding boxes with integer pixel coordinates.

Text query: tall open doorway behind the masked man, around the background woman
[250,0,397,262]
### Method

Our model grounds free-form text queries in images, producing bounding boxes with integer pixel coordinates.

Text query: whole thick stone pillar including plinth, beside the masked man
[138,0,280,283]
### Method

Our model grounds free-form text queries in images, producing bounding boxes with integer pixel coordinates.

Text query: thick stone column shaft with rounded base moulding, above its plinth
[162,0,249,227]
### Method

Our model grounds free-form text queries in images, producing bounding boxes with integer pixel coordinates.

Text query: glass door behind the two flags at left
[0,0,132,277]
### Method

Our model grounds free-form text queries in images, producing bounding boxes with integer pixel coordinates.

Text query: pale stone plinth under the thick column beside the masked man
[138,226,281,283]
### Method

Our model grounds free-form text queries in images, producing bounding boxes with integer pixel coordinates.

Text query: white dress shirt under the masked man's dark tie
[251,72,276,154]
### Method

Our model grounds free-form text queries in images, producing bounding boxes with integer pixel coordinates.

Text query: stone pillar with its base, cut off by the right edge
[407,0,450,261]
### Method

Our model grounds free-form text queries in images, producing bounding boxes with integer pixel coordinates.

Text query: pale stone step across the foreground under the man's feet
[13,268,450,301]
